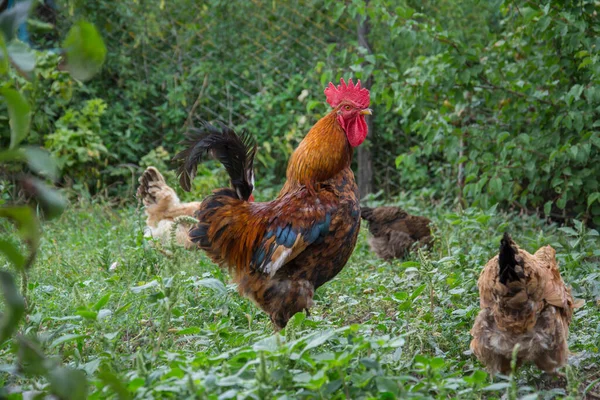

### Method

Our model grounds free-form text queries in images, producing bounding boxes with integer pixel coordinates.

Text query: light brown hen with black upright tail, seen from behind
[471,233,580,374]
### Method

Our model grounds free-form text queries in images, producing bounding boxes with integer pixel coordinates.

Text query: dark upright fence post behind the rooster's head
[356,0,373,198]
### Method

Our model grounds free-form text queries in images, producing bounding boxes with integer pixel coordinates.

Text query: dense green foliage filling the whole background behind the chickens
[0,0,600,224]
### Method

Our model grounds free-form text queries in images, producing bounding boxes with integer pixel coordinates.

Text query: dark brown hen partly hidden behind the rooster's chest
[360,207,432,260]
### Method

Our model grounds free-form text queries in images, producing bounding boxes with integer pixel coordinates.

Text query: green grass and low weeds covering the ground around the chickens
[0,198,600,399]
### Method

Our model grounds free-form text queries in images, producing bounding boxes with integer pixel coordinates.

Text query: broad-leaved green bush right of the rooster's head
[358,1,600,224]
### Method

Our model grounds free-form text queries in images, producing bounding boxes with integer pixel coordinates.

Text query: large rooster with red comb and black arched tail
[139,79,371,329]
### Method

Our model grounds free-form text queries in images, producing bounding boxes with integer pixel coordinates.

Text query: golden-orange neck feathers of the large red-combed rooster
[286,109,352,192]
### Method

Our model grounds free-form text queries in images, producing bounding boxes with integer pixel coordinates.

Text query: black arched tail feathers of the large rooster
[173,121,257,200]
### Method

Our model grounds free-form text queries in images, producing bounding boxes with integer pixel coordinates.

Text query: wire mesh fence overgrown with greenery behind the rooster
[50,0,408,195]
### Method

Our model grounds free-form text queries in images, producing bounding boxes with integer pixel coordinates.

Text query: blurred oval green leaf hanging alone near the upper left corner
[63,21,106,81]
